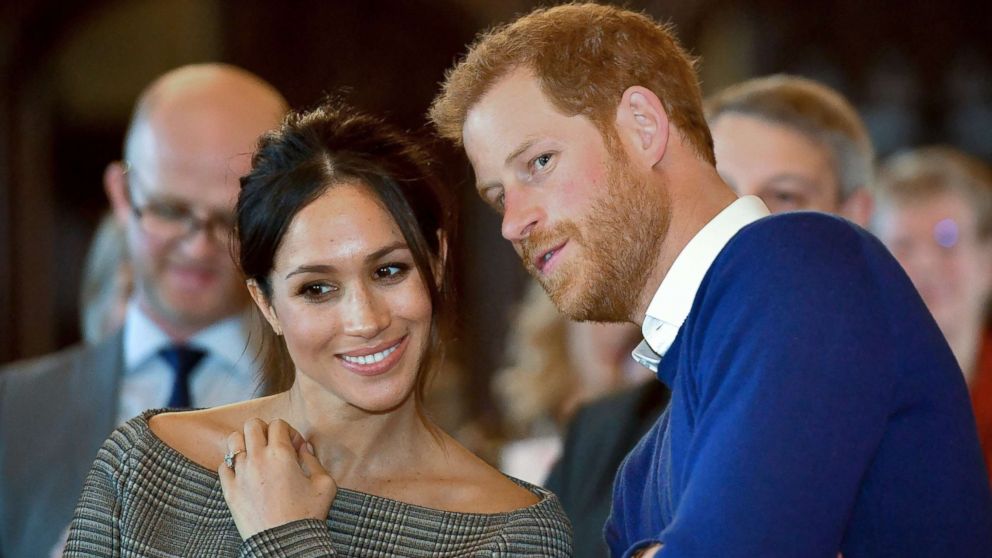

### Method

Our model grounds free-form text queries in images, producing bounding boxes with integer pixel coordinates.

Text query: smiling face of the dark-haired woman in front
[250,184,432,412]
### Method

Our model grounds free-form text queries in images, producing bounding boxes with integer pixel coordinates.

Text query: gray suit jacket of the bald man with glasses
[0,333,124,558]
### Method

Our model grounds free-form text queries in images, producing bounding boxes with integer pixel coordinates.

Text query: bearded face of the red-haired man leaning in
[463,71,671,321]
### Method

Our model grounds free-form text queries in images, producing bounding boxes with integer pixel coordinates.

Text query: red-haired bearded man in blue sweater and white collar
[431,4,992,557]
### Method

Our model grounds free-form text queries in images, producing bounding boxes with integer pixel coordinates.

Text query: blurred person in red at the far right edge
[872,147,992,484]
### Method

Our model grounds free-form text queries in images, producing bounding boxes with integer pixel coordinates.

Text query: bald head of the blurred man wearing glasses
[105,64,288,338]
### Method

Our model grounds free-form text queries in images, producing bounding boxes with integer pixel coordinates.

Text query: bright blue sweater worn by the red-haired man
[606,213,992,558]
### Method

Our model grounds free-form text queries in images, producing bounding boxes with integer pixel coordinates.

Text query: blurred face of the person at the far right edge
[874,192,992,338]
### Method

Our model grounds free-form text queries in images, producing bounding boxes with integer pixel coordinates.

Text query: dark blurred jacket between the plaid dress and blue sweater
[545,380,669,558]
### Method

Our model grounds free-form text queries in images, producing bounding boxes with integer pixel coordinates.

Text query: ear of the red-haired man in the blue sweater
[616,85,670,168]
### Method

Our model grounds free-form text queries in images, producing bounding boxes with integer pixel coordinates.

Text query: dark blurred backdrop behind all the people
[0,0,992,428]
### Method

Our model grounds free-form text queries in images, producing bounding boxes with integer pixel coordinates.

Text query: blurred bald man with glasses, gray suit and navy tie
[0,64,287,558]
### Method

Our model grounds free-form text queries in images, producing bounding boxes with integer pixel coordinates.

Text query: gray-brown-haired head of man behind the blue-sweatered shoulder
[704,75,875,227]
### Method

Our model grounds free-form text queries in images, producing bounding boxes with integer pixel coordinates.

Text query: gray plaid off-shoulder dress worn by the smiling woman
[65,411,572,557]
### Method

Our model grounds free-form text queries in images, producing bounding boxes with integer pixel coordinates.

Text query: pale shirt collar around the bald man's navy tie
[124,299,255,373]
